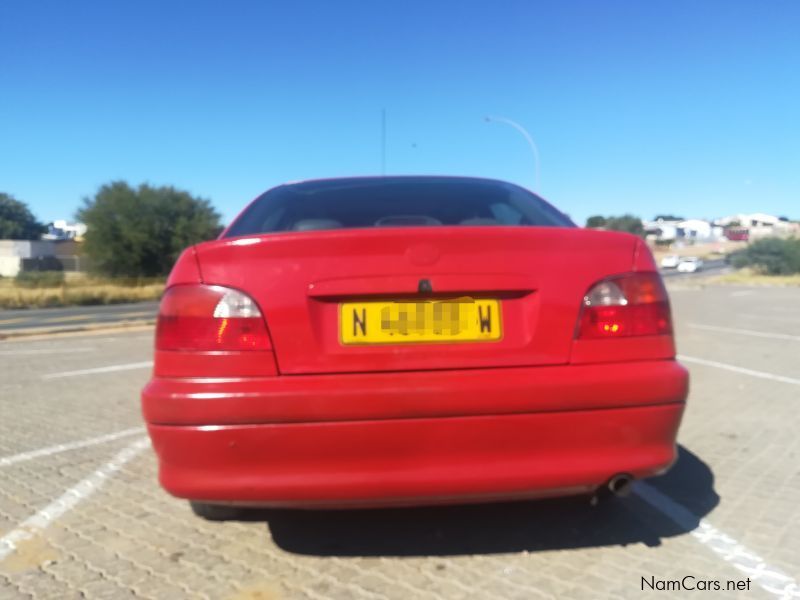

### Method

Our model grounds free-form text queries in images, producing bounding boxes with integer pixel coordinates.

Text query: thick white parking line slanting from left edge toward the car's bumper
[0,438,150,561]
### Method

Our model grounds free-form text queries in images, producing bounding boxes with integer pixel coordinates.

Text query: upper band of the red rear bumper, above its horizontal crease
[142,358,688,425]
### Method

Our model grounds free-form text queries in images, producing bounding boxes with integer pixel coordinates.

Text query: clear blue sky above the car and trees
[0,0,800,222]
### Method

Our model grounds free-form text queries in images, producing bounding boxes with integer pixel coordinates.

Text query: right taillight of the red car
[575,273,672,339]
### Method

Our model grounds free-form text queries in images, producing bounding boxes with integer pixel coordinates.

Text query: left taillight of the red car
[156,284,271,351]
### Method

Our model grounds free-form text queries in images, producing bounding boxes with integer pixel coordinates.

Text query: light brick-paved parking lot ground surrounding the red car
[0,281,800,600]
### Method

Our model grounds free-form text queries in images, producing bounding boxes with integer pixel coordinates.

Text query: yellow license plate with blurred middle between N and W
[339,298,503,345]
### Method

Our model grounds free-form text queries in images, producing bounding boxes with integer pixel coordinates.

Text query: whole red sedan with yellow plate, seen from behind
[142,177,688,518]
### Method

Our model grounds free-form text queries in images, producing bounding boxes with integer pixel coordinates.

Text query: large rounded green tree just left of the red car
[77,181,221,277]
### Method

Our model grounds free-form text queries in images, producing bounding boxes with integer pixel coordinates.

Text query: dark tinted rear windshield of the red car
[225,177,574,237]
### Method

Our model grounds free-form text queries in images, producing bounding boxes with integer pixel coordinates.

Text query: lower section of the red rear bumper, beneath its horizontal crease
[149,403,683,508]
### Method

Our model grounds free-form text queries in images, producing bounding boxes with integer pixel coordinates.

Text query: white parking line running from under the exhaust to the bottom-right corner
[633,482,800,599]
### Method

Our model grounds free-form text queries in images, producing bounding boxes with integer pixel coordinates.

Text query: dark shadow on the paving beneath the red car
[220,446,719,556]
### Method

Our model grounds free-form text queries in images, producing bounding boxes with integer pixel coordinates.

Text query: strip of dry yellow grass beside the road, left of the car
[0,276,164,308]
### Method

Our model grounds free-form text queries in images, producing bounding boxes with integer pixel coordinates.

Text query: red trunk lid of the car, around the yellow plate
[197,226,636,375]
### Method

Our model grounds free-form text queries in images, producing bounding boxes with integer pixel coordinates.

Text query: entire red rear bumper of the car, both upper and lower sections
[143,361,687,507]
